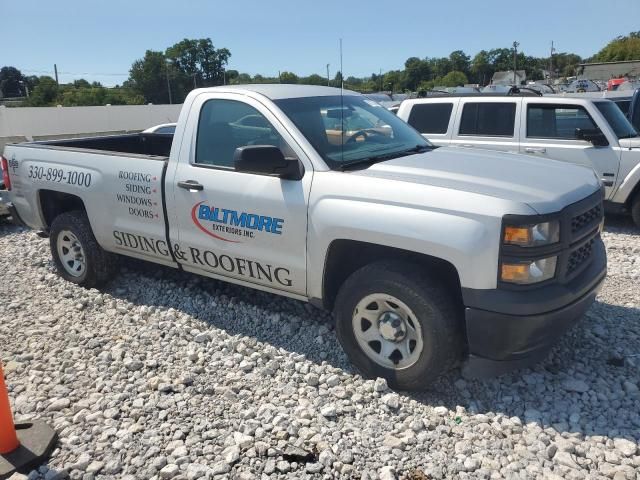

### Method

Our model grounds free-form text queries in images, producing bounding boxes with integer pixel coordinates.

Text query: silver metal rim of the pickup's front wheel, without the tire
[352,293,424,370]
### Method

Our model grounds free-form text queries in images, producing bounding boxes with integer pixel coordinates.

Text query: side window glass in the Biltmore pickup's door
[195,100,288,168]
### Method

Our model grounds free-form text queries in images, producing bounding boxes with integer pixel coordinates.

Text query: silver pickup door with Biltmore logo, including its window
[167,93,313,295]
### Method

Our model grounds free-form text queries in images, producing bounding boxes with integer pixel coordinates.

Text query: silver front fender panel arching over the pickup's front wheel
[307,198,501,298]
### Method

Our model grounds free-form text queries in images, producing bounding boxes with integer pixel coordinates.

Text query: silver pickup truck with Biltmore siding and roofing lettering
[2,85,606,389]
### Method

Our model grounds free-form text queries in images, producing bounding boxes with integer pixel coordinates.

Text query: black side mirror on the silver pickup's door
[233,145,304,180]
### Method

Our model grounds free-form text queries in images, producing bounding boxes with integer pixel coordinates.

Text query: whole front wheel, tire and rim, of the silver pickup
[335,262,463,390]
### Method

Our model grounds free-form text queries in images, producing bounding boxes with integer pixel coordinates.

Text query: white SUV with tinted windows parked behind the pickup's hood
[398,94,640,226]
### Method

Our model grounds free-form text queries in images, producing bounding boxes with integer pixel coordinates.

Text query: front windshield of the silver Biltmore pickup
[275,95,432,170]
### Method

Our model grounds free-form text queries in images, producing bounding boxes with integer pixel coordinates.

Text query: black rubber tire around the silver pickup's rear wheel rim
[49,210,117,288]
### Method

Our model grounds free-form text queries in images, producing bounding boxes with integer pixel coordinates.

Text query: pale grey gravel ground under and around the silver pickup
[0,220,640,480]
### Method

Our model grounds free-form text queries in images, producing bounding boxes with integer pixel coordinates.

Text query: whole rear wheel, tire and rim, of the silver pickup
[49,210,116,288]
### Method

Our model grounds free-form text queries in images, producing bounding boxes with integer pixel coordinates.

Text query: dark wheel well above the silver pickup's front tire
[322,240,462,310]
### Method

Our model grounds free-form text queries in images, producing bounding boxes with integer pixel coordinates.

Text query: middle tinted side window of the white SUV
[459,102,516,137]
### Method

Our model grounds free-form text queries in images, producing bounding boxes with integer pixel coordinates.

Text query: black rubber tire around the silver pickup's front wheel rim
[334,261,463,390]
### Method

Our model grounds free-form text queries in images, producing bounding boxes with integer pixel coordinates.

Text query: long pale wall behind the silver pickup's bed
[0,105,182,149]
